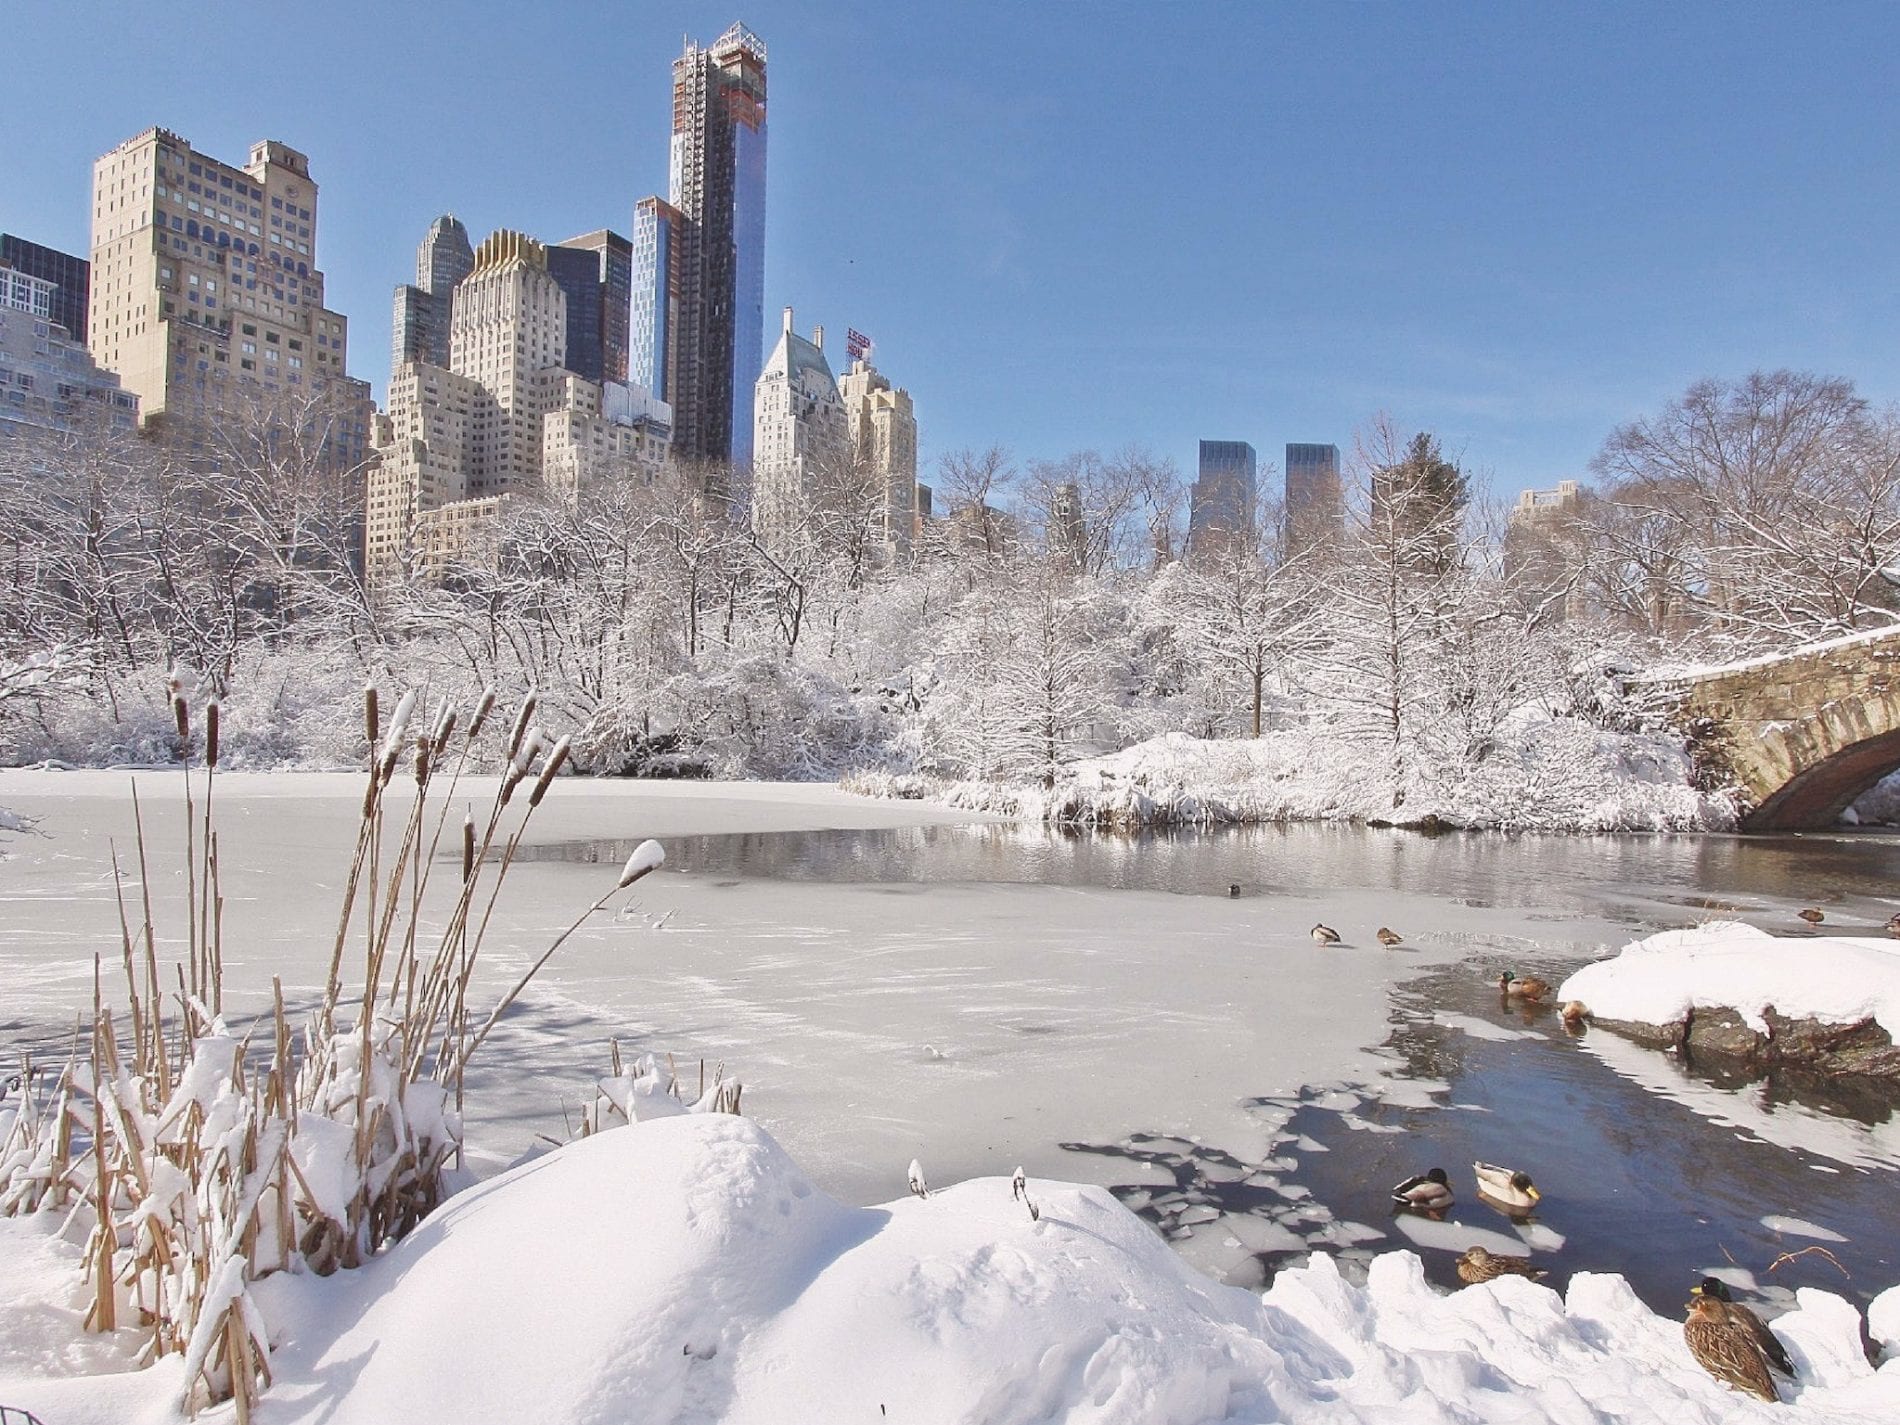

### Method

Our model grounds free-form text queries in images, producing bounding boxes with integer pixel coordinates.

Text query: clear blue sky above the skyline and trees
[0,0,1900,494]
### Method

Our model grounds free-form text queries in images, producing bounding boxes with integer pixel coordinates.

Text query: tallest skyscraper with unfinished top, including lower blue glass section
[629,25,766,480]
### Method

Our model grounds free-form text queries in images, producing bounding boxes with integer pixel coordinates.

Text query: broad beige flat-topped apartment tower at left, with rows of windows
[87,129,374,467]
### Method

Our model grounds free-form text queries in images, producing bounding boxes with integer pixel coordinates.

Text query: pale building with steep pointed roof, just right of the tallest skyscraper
[751,308,849,549]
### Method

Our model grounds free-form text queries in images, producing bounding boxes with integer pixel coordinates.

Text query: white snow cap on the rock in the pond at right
[1558,922,1900,1043]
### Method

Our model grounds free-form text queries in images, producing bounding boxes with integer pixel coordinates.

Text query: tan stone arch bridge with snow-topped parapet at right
[1645,629,1900,830]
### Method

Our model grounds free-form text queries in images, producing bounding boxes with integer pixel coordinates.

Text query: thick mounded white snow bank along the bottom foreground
[0,1115,1900,1425]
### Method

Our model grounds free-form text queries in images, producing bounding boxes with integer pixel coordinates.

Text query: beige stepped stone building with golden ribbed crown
[365,230,671,581]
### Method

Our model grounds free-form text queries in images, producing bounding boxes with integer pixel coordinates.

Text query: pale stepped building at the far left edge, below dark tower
[0,260,139,439]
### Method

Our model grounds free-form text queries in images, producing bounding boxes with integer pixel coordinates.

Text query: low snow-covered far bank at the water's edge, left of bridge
[862,713,1735,830]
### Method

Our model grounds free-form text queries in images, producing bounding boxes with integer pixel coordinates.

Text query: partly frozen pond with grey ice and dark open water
[0,773,1900,1307]
